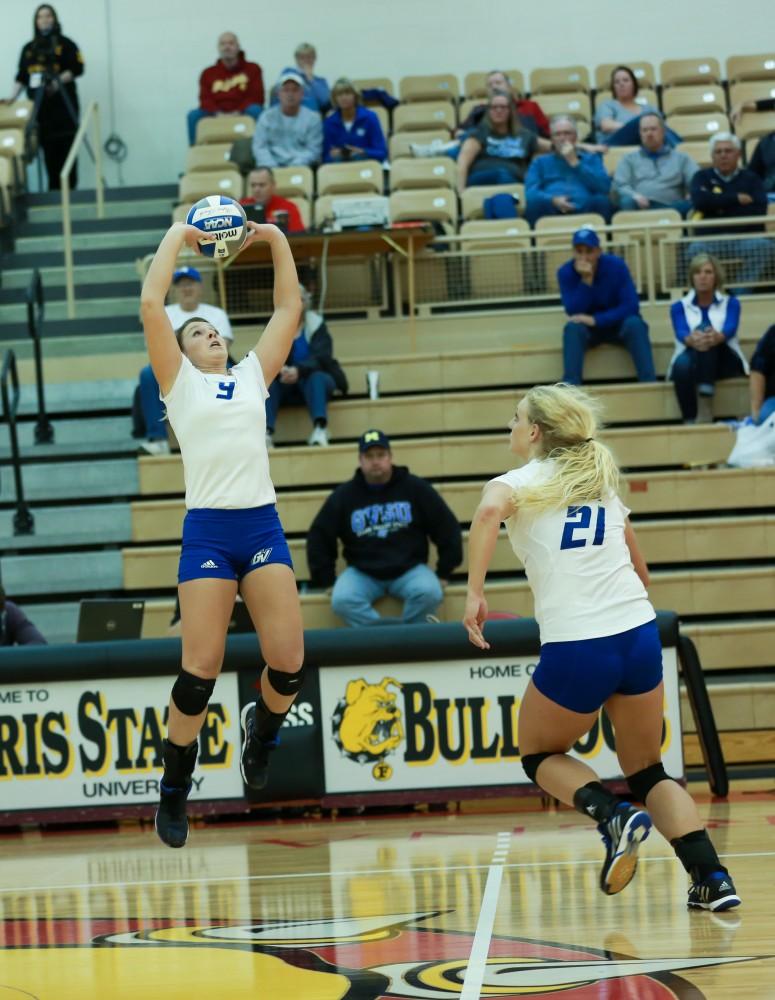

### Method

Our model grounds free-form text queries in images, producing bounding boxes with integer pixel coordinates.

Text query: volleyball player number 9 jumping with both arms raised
[141,222,304,847]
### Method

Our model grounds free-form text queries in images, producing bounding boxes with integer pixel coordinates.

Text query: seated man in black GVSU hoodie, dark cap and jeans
[307,430,463,627]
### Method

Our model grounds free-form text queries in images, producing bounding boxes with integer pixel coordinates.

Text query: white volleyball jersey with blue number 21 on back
[492,460,656,643]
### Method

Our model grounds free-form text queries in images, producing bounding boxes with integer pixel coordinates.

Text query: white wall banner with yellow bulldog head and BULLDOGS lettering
[320,648,683,795]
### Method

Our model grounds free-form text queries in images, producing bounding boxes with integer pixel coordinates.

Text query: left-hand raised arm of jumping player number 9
[140,222,202,395]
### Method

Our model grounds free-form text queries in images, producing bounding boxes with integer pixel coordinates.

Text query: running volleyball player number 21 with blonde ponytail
[463,384,740,912]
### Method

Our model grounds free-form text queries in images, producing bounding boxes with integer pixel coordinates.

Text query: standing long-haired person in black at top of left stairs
[2,3,84,191]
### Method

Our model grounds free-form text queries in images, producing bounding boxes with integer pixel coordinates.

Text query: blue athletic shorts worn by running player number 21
[533,621,662,712]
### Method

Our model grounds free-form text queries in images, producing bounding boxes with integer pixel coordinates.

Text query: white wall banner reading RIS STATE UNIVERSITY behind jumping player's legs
[0,673,244,812]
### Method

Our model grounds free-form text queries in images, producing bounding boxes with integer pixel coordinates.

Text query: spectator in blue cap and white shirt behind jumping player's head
[133,267,235,455]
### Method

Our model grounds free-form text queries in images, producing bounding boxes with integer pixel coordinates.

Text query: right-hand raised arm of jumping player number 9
[252,222,302,385]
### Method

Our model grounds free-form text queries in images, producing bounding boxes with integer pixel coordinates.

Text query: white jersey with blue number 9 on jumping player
[161,351,276,510]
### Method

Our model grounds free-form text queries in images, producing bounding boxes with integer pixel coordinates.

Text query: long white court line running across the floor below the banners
[0,851,775,896]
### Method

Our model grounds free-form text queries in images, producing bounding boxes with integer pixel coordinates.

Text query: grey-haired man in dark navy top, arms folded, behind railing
[688,132,775,294]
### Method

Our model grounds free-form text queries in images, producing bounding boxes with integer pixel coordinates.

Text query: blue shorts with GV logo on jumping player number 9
[178,503,293,583]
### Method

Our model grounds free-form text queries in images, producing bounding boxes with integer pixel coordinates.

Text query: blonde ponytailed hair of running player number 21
[515,382,619,513]
